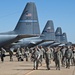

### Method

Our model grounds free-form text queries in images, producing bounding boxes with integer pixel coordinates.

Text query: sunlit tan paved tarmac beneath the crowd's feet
[0,53,75,75]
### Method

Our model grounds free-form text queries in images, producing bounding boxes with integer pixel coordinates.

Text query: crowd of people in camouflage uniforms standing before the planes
[1,46,75,70]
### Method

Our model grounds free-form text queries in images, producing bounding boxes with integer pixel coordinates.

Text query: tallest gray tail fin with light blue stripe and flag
[14,2,40,34]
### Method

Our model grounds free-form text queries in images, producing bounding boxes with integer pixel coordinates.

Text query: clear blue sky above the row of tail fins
[0,0,75,43]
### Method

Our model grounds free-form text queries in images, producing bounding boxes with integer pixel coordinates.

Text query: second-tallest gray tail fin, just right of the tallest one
[40,20,55,41]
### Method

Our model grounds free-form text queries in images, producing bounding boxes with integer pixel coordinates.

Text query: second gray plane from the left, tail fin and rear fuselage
[12,20,55,47]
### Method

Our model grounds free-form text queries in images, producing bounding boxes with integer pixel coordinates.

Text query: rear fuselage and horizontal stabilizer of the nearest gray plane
[0,34,38,47]
